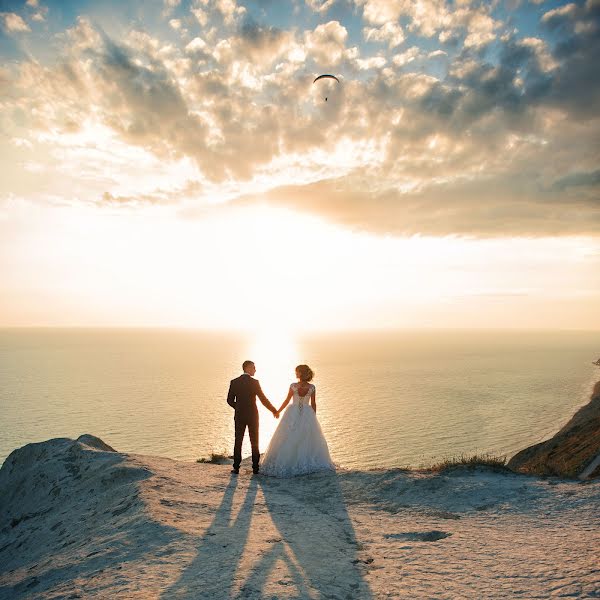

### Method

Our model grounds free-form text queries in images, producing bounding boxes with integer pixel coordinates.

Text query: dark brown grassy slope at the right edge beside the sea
[508,381,600,479]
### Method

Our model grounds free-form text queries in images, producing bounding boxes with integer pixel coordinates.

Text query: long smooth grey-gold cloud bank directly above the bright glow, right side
[236,171,600,237]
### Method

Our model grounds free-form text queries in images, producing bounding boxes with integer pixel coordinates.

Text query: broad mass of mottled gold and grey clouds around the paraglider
[0,0,600,235]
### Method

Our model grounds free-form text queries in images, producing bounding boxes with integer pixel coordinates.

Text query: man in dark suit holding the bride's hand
[227,360,279,474]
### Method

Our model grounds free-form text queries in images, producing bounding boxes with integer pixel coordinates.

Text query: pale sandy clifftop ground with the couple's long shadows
[0,439,600,599]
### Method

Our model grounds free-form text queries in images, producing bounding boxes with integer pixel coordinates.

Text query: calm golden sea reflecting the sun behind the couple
[0,329,600,468]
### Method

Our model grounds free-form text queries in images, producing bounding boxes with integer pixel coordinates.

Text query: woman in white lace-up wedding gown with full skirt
[260,365,335,477]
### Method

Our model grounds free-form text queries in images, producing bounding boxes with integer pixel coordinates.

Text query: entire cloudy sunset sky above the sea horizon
[0,0,600,331]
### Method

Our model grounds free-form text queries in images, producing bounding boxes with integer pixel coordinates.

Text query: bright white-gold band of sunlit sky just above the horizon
[0,198,600,336]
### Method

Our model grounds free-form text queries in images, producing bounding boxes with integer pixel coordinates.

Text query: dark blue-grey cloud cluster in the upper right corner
[390,3,600,134]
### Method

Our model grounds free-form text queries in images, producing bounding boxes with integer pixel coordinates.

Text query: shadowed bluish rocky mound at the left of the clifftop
[0,434,157,600]
